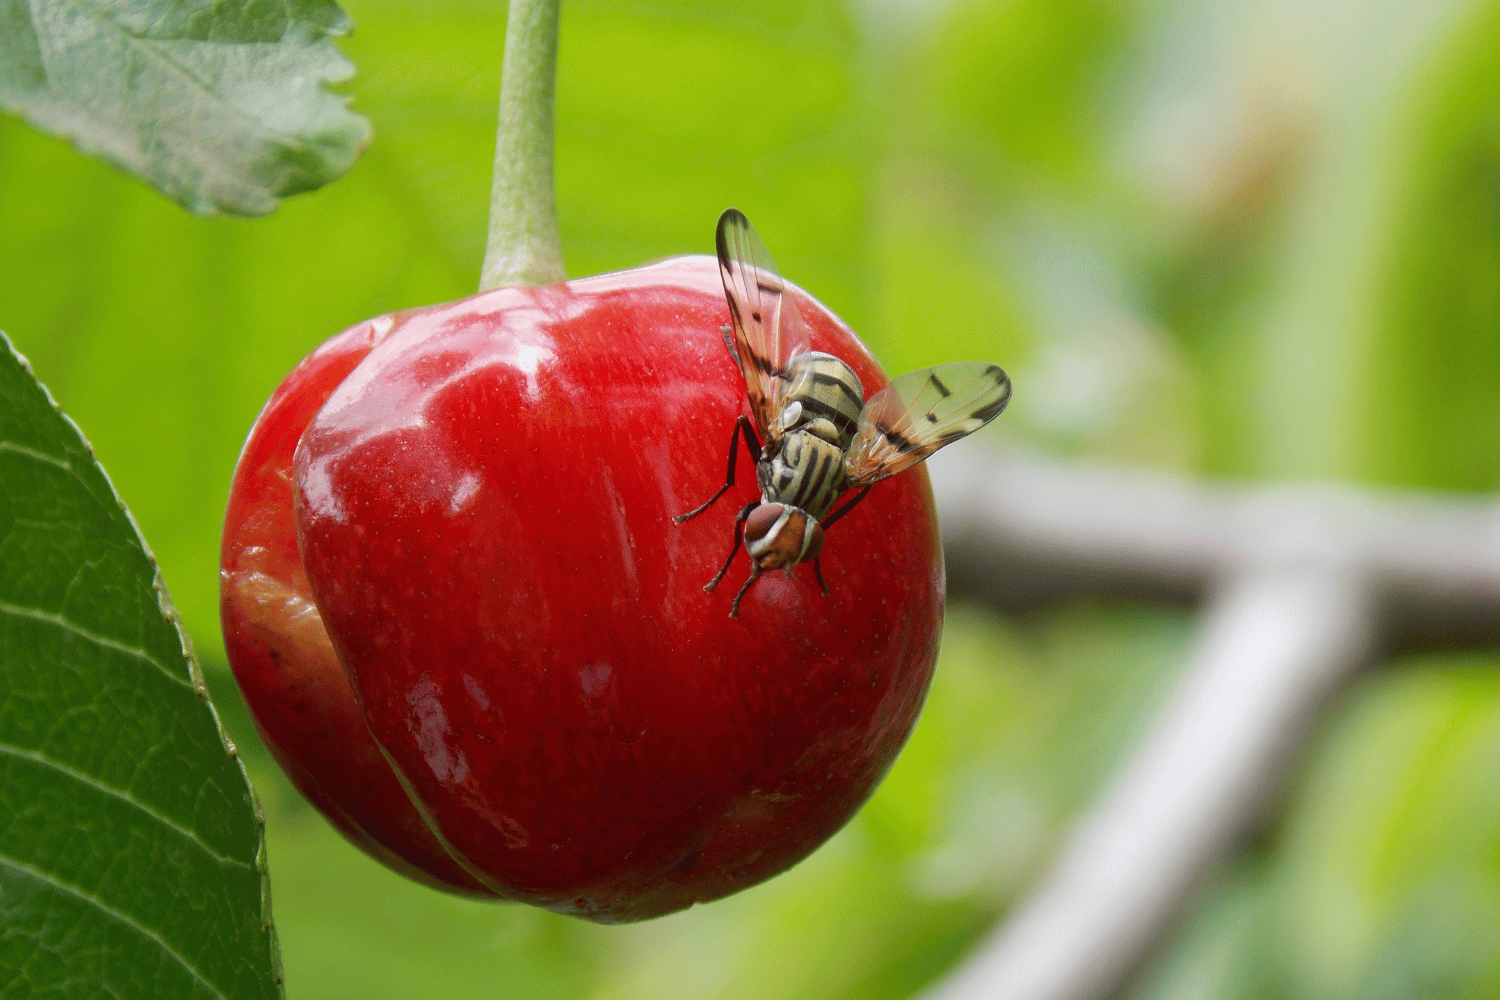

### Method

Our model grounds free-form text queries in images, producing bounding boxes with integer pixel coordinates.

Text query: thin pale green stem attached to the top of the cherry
[479,0,567,291]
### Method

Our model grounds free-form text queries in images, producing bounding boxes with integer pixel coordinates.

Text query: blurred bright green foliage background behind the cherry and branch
[0,0,1500,1000]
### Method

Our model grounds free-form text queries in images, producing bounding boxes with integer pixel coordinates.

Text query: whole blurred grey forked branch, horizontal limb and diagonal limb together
[927,448,1500,1000]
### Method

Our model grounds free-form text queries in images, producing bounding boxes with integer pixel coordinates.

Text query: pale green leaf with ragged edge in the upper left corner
[0,0,371,216]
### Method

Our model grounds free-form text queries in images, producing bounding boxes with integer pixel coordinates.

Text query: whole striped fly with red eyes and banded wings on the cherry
[675,208,1011,618]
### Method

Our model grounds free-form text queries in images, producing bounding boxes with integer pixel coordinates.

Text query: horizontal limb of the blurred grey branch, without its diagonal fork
[927,445,1500,645]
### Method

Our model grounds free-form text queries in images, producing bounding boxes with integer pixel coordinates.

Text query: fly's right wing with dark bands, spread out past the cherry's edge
[848,361,1011,487]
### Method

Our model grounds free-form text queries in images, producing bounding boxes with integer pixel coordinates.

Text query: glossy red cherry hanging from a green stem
[224,251,944,922]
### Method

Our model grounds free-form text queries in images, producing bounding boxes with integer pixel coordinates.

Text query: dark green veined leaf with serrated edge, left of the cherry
[0,333,281,1000]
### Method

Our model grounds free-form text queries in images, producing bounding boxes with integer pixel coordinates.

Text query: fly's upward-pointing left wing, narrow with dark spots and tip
[716,208,810,438]
